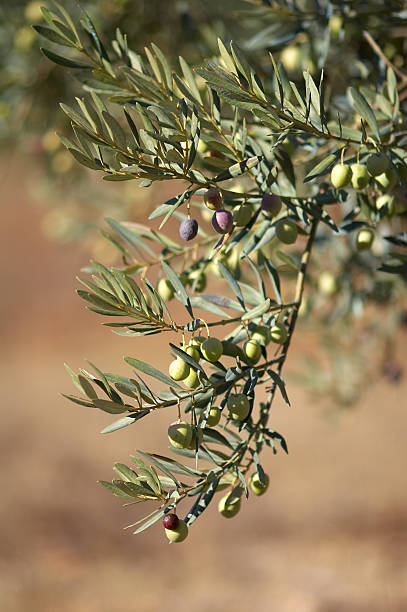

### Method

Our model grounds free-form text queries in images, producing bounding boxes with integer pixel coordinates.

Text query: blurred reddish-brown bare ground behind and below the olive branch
[0,159,407,612]
